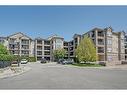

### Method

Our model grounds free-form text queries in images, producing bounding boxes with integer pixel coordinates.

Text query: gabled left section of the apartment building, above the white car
[6,32,34,57]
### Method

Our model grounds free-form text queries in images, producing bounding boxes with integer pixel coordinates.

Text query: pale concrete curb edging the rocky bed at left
[0,67,31,79]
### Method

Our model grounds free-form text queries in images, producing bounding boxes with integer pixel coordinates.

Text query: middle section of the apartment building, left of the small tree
[35,35,64,61]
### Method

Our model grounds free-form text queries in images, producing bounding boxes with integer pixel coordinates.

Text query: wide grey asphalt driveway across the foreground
[0,62,127,89]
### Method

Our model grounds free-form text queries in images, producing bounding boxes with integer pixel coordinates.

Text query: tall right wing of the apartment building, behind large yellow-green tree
[69,27,127,65]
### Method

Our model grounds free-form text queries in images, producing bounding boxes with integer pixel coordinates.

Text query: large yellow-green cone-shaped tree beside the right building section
[76,36,98,63]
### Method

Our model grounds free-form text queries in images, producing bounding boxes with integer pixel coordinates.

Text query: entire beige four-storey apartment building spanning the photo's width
[0,27,127,65]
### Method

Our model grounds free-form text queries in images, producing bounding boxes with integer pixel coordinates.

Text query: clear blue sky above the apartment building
[0,6,127,41]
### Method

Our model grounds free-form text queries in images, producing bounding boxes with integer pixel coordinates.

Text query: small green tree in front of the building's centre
[53,48,66,60]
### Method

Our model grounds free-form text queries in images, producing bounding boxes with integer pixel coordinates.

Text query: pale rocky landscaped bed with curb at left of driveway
[0,66,31,78]
